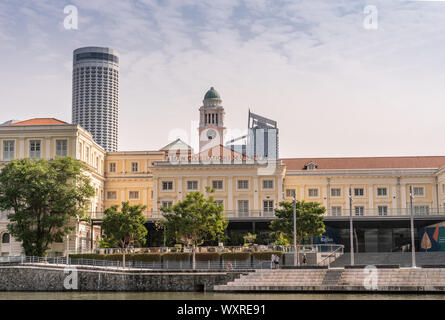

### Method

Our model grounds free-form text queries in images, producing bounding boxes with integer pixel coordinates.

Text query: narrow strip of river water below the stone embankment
[0,292,445,300]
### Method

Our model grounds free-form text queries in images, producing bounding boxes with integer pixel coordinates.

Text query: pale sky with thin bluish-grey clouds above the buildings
[0,0,445,157]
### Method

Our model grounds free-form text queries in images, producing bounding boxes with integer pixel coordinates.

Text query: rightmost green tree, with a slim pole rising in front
[270,201,326,264]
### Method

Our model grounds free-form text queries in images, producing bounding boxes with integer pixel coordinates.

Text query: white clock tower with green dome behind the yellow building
[198,87,226,152]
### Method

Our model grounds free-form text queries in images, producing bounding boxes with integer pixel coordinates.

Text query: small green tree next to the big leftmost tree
[102,202,148,266]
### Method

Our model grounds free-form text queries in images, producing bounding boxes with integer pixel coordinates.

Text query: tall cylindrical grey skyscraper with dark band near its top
[72,47,119,151]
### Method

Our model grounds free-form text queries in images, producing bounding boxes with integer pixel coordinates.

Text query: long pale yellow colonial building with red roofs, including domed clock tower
[0,88,445,255]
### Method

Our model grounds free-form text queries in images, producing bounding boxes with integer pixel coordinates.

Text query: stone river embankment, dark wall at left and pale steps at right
[0,264,445,293]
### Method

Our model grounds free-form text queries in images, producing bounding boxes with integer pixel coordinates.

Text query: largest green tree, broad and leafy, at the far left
[0,157,95,256]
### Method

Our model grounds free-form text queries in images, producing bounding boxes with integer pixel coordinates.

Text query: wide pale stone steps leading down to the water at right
[213,268,445,292]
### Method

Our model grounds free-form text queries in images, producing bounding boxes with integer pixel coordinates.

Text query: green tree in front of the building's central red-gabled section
[159,189,228,269]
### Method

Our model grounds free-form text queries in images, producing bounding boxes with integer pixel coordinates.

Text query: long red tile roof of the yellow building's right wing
[281,156,445,170]
